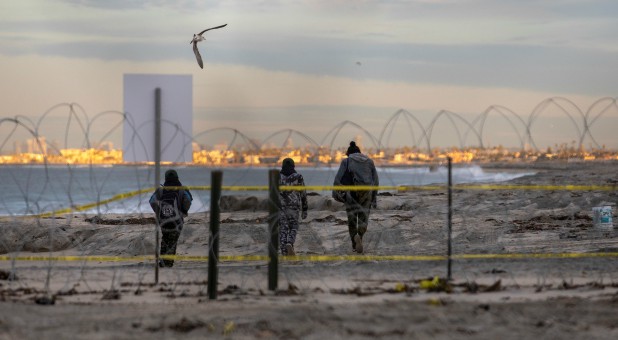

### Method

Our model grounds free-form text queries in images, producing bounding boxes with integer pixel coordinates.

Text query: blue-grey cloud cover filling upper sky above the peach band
[0,0,618,96]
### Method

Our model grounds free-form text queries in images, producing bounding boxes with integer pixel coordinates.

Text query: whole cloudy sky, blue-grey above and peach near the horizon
[0,0,618,148]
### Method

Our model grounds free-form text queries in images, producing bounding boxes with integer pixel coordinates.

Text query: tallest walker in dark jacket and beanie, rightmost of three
[333,141,380,254]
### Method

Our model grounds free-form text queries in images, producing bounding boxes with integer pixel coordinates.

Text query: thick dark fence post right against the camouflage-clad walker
[268,169,279,290]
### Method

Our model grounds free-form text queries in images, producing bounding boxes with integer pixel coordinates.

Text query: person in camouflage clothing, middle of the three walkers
[279,158,308,256]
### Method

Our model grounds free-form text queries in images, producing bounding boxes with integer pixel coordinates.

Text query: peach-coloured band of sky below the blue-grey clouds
[0,55,615,145]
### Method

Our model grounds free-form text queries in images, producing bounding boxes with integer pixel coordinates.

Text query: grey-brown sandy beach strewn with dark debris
[0,162,618,339]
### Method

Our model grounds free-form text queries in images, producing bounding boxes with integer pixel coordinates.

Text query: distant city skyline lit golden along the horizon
[0,137,618,167]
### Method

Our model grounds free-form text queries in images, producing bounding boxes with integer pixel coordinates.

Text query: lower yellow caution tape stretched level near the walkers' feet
[0,252,618,262]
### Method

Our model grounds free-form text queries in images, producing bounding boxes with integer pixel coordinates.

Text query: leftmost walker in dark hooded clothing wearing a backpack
[150,169,193,267]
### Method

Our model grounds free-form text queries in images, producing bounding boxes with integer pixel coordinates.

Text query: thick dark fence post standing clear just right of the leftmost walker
[208,171,223,300]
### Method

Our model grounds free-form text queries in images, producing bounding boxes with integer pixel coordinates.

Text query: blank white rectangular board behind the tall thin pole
[122,74,193,163]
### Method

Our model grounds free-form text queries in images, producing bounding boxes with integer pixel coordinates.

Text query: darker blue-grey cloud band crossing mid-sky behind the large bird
[0,28,618,96]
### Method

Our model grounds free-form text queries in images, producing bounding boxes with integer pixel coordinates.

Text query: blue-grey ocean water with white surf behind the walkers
[0,165,532,216]
